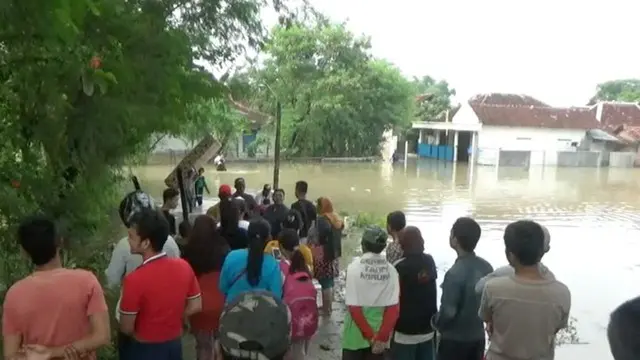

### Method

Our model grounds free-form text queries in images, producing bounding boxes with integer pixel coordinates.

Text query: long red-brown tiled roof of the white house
[469,102,600,129]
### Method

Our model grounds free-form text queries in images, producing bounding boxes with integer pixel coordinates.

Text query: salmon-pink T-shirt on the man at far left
[2,269,107,359]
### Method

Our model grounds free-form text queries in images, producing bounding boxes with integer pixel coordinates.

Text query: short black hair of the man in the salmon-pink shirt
[18,215,61,266]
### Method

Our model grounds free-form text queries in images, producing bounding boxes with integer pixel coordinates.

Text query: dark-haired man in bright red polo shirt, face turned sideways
[119,209,202,360]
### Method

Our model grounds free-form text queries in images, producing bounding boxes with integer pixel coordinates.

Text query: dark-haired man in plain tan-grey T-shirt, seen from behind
[479,220,571,360]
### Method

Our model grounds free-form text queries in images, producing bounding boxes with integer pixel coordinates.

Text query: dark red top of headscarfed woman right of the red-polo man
[189,271,224,331]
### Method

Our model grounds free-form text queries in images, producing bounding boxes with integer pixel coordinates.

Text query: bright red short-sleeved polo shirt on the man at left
[120,253,200,343]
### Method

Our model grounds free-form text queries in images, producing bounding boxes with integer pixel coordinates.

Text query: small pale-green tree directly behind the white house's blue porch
[413,76,456,121]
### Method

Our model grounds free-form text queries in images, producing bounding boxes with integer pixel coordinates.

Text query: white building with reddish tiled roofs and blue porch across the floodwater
[413,94,640,166]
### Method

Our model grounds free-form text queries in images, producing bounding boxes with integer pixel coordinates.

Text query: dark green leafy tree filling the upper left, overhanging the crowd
[0,0,282,354]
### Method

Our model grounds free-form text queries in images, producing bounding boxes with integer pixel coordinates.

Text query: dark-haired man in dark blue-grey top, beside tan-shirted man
[434,217,493,360]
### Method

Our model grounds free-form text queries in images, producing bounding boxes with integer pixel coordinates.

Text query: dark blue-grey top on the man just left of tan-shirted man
[434,254,493,341]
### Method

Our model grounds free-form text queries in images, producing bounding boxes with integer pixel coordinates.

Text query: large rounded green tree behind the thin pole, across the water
[237,18,413,157]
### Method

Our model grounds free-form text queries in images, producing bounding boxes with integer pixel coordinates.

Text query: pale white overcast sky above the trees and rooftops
[258,0,640,106]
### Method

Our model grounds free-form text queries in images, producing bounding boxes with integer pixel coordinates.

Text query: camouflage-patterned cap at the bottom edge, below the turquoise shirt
[219,291,291,360]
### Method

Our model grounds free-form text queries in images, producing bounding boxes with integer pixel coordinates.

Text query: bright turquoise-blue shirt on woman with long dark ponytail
[220,249,282,303]
